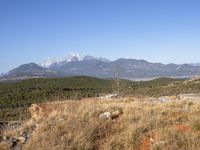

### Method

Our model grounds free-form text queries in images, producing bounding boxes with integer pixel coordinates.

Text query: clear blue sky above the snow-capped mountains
[0,0,200,72]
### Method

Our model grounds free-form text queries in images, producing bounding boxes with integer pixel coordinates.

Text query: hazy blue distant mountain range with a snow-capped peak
[0,53,200,80]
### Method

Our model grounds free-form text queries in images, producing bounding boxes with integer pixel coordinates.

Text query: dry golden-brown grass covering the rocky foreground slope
[0,98,200,150]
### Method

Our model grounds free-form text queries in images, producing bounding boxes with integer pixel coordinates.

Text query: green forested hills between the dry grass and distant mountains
[0,77,200,121]
